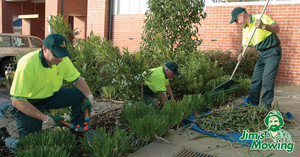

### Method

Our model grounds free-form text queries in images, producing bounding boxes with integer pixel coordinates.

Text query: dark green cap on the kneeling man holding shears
[44,33,71,58]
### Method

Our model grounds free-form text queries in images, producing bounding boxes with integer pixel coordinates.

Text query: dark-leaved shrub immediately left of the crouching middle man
[108,49,149,100]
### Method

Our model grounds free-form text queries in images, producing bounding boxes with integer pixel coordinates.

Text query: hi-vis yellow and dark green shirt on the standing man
[243,14,280,50]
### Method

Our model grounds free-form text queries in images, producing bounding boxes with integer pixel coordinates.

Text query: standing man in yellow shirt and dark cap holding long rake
[230,7,281,107]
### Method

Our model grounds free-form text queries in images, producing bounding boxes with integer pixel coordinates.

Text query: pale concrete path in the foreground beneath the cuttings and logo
[129,85,300,157]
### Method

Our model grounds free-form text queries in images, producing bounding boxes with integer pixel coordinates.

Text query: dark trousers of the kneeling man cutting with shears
[6,87,85,151]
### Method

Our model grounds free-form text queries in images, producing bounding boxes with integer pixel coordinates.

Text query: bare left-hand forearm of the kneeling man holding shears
[12,99,47,121]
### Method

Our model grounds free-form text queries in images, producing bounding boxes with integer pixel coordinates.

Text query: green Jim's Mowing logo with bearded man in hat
[240,110,295,153]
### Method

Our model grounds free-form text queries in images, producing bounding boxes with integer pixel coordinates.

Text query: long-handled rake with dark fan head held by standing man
[211,0,270,96]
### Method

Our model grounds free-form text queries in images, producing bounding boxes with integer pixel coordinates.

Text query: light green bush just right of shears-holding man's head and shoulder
[71,36,120,93]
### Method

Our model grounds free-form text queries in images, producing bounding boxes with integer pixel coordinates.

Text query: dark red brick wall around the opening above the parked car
[1,1,45,39]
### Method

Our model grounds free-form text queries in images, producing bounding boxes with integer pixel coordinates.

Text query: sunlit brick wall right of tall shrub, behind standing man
[200,4,300,85]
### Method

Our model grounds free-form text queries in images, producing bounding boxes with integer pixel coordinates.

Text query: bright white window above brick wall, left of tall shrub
[114,0,148,14]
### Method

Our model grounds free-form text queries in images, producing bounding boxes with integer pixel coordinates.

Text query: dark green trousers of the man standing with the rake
[248,46,281,107]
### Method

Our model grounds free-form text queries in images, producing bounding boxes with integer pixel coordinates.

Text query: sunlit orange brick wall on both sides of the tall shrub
[113,2,300,85]
